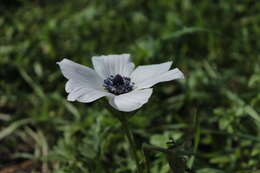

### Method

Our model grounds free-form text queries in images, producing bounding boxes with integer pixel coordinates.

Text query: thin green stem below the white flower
[120,117,141,173]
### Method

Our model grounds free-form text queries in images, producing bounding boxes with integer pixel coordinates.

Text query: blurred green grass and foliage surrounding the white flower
[0,0,260,173]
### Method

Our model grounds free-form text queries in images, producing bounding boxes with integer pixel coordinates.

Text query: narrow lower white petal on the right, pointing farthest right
[136,68,184,89]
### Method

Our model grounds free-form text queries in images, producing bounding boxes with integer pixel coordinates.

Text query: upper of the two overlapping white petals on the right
[131,61,172,85]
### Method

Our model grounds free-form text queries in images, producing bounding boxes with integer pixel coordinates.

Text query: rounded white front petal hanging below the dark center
[109,88,153,112]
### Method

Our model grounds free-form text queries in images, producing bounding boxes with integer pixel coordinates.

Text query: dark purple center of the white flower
[103,74,134,95]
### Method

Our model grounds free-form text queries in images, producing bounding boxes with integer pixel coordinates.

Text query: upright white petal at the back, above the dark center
[92,54,134,79]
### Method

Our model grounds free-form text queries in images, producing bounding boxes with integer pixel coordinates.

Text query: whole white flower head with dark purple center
[57,54,184,112]
